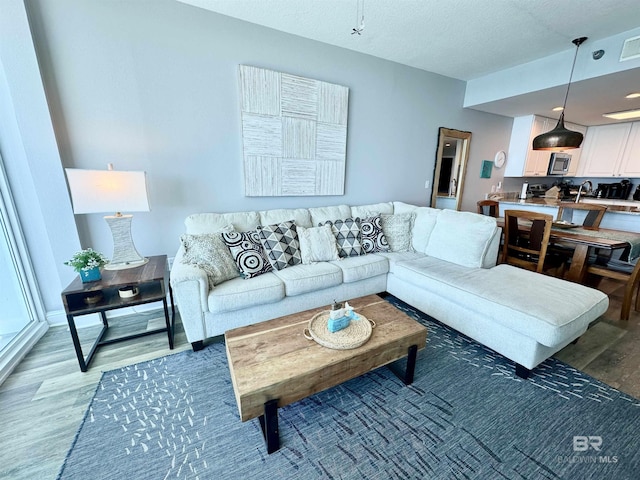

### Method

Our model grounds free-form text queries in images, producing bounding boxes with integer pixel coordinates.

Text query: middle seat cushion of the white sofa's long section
[273,262,342,297]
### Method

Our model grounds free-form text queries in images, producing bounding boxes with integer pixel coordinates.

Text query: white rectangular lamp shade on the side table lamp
[65,168,149,213]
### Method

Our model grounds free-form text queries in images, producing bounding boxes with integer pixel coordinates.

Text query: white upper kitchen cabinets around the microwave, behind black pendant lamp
[504,115,587,177]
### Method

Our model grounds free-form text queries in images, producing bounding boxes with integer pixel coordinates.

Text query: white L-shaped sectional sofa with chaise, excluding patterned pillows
[171,202,609,378]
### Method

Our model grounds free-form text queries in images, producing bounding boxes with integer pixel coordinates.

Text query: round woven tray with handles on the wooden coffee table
[304,310,376,350]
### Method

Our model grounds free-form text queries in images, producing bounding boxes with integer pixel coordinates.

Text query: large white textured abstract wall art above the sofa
[239,65,349,197]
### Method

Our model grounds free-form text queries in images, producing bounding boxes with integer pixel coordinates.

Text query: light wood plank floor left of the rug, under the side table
[0,310,191,480]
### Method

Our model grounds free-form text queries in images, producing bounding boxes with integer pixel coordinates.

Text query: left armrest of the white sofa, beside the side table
[169,246,209,343]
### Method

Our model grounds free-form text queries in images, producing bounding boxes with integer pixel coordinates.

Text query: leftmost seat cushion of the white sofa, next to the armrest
[207,273,285,315]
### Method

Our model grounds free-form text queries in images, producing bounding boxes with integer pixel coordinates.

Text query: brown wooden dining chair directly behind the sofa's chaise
[502,210,553,273]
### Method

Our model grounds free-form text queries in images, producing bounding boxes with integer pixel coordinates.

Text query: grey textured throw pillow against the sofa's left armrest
[180,233,239,287]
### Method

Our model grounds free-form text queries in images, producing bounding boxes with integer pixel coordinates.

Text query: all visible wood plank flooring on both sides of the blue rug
[0,282,640,480]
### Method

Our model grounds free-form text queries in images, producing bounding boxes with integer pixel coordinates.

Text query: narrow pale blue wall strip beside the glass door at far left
[0,0,80,311]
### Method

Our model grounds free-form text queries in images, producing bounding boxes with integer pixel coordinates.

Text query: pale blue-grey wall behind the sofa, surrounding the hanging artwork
[8,0,512,316]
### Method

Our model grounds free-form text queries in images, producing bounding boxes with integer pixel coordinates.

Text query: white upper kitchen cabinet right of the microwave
[577,122,640,177]
